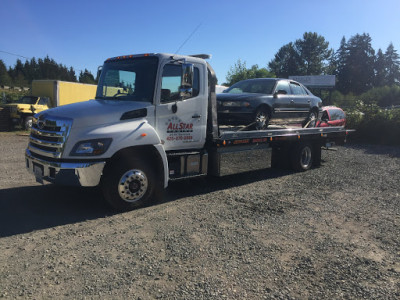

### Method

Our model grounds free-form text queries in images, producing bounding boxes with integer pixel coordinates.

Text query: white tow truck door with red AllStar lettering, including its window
[156,64,207,150]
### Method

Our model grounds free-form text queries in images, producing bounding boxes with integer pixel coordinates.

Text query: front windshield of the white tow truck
[96,57,158,102]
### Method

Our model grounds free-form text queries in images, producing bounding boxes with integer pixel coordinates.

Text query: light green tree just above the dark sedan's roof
[225,59,275,86]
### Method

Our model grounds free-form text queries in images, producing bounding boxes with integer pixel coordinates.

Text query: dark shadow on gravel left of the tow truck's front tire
[0,185,112,237]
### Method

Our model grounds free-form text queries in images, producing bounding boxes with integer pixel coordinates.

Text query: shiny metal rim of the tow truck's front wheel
[118,170,148,202]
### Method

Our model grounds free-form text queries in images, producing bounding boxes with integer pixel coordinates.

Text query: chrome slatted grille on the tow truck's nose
[28,114,72,158]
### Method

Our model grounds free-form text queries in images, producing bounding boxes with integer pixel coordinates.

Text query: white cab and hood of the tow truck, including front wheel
[26,54,214,208]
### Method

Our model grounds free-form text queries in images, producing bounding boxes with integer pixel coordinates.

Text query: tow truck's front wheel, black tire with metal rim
[101,158,164,211]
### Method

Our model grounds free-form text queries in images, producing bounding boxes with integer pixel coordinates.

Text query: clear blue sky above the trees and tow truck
[0,0,400,83]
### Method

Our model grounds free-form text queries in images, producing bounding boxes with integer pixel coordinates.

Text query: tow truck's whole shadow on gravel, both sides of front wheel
[0,169,292,237]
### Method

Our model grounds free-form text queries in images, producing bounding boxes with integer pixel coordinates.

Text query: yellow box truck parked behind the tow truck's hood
[6,80,97,129]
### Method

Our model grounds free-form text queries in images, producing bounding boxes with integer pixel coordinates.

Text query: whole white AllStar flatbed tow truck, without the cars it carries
[25,53,349,210]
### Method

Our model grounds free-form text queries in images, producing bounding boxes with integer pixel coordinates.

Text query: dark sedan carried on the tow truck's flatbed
[217,78,322,130]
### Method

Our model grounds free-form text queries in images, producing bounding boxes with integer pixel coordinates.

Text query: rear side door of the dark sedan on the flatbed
[290,81,311,121]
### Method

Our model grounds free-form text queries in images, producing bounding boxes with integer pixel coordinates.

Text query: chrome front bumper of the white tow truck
[25,149,106,186]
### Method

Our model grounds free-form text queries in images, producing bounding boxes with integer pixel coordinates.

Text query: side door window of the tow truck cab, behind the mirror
[161,64,200,103]
